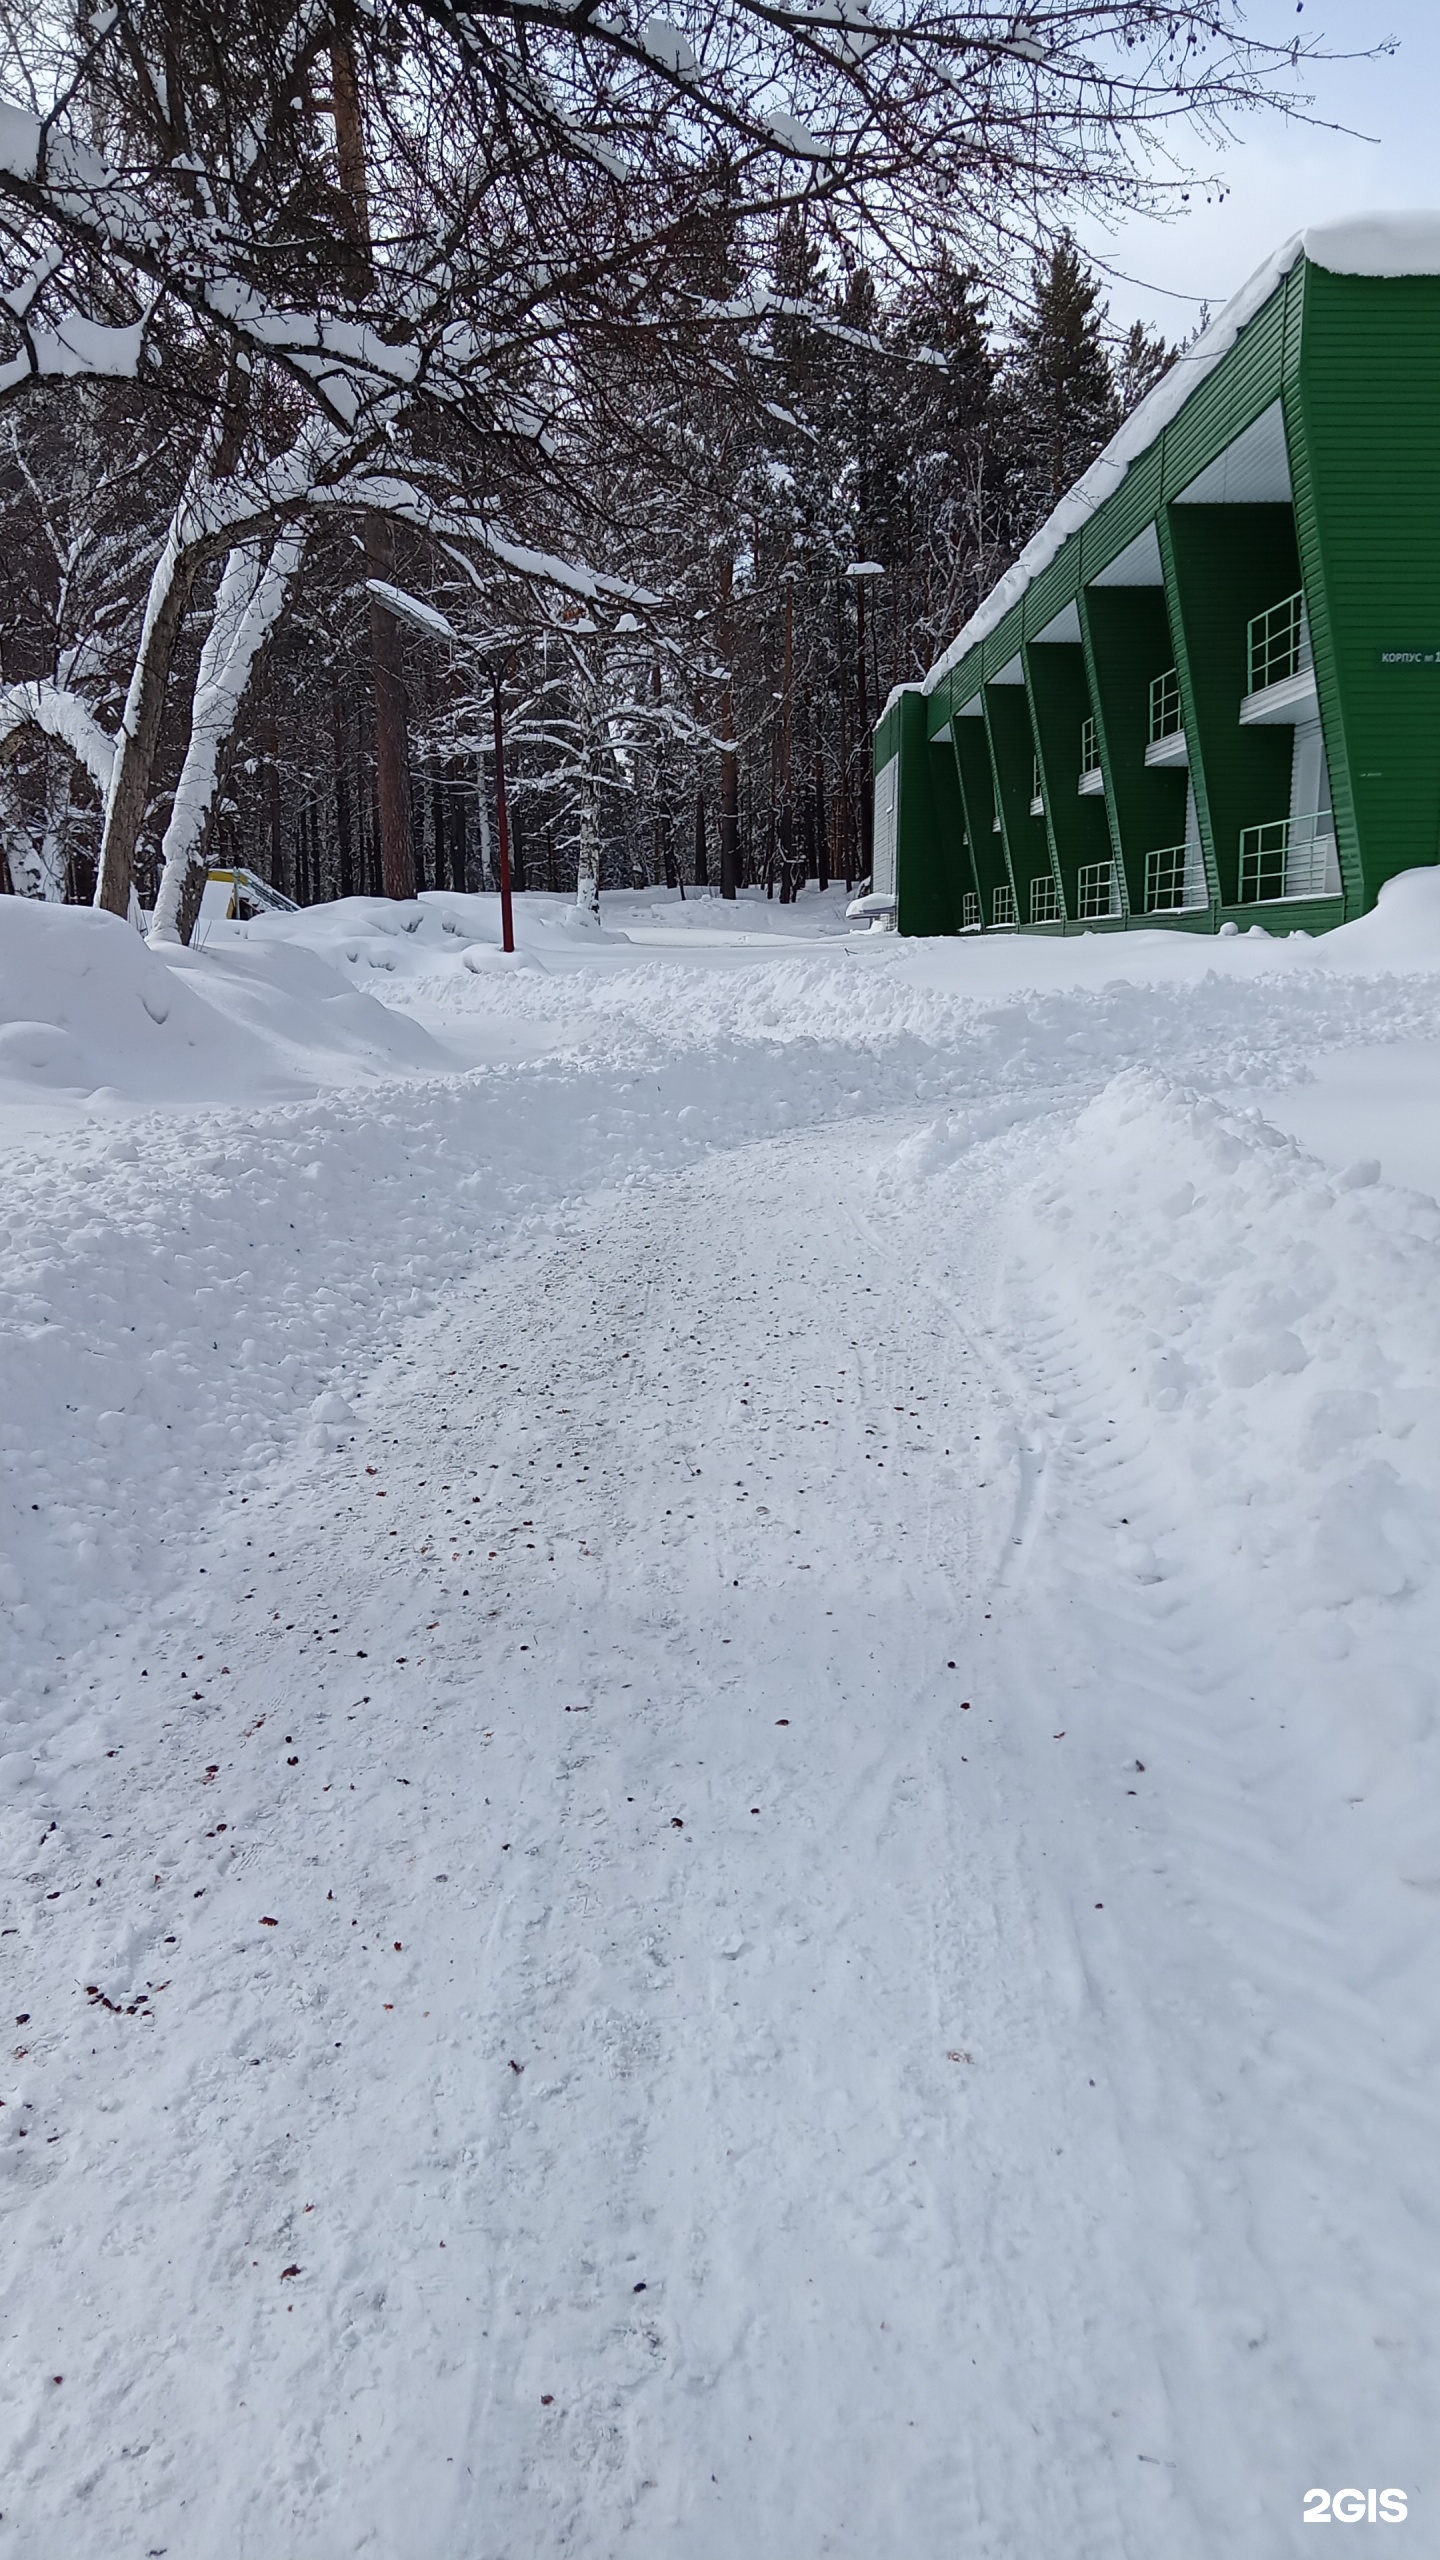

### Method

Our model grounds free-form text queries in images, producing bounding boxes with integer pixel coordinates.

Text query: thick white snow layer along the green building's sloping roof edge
[925,212,1440,694]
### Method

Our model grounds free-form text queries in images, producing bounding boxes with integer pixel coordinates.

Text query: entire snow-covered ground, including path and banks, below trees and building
[0,876,1440,2560]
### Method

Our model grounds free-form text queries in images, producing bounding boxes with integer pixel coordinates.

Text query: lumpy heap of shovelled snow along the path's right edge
[1015,1070,1440,1884]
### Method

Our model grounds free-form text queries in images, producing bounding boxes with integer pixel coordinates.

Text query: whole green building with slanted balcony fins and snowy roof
[871,215,1440,934]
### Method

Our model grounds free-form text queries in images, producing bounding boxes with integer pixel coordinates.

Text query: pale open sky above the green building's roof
[1084,0,1440,338]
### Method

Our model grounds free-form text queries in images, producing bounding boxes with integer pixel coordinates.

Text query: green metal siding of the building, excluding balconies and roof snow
[876,259,1440,932]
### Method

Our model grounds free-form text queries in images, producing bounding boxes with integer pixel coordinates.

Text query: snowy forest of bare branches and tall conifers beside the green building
[0,0,1294,937]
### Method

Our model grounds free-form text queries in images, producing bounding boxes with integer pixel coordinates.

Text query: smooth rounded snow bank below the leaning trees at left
[0,899,451,1103]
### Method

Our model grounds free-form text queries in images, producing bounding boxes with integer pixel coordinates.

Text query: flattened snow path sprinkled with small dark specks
[2,1134,1168,2560]
